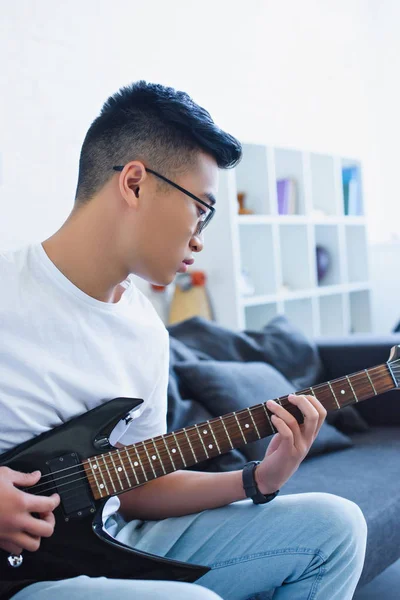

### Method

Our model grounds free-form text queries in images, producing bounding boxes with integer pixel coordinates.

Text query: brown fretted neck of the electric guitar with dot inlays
[83,363,397,500]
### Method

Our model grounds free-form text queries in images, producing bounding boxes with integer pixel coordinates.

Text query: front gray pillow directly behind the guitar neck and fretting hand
[175,360,352,460]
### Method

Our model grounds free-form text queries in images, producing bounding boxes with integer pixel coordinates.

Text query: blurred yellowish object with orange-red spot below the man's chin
[168,271,214,325]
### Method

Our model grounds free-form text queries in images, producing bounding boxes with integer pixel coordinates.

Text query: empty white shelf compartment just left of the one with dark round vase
[279,224,313,293]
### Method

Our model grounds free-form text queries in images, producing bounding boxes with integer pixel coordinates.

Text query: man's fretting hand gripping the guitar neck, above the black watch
[255,394,326,494]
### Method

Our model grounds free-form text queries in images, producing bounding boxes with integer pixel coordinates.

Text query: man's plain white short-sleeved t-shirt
[0,244,169,510]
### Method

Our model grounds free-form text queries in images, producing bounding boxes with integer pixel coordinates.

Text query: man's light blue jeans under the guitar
[14,493,367,600]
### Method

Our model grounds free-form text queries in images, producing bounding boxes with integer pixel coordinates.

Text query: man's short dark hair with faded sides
[75,81,242,204]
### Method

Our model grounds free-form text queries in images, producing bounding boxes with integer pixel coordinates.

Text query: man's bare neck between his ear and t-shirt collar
[42,200,129,302]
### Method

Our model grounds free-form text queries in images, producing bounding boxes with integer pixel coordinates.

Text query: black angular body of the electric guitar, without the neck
[0,398,209,583]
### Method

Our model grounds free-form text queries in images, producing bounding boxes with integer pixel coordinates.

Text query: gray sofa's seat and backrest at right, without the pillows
[283,334,400,588]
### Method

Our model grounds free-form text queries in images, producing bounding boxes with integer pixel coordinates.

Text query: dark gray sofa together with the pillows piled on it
[168,317,400,599]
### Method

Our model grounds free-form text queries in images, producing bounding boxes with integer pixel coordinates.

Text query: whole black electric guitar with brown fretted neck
[0,345,400,583]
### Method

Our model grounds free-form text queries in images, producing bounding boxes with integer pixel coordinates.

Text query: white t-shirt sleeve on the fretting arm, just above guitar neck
[114,335,169,445]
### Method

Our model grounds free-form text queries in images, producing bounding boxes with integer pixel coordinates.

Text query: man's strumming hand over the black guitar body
[0,467,60,554]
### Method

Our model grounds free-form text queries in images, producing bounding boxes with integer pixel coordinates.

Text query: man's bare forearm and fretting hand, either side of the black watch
[120,395,326,520]
